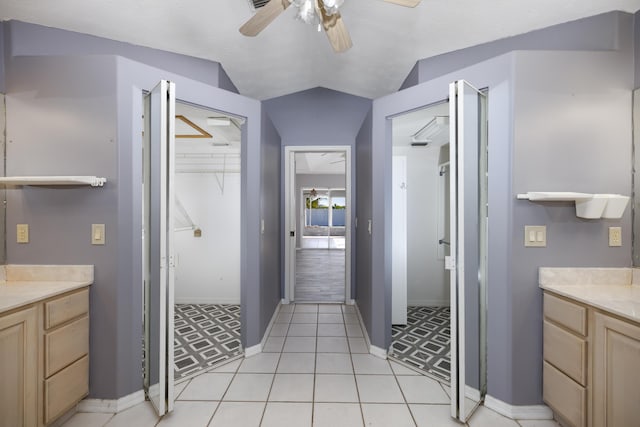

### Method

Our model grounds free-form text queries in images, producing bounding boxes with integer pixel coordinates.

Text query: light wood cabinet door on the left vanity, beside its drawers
[0,307,38,427]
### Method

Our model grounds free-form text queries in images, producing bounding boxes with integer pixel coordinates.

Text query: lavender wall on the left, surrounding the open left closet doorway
[5,24,264,399]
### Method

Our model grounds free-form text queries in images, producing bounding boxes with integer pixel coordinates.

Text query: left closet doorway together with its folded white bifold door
[141,81,244,415]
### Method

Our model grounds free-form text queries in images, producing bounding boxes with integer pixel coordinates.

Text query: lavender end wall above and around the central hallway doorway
[262,88,371,297]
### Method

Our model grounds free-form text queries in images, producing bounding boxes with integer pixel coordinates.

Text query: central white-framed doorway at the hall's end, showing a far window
[285,146,351,303]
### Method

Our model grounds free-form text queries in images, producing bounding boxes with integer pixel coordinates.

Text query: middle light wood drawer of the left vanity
[44,316,89,378]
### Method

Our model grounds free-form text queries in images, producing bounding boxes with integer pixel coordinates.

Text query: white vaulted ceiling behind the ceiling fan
[0,0,640,100]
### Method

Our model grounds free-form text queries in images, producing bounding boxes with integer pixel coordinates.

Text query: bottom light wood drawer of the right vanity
[542,362,587,427]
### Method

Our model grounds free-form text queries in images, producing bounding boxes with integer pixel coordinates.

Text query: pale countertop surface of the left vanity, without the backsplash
[0,280,92,314]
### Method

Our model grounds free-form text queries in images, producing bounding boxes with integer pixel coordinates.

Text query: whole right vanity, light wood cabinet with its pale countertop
[539,268,640,427]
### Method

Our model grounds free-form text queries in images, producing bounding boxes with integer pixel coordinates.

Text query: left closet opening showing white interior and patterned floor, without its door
[174,101,243,382]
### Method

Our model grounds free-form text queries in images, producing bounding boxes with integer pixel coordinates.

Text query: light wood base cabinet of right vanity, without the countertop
[543,292,640,427]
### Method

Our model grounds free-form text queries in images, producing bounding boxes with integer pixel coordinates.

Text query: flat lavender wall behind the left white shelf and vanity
[6,56,122,398]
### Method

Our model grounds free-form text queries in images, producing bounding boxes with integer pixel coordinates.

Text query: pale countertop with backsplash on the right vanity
[539,267,640,323]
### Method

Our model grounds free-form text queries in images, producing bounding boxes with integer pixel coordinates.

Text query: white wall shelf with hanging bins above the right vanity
[517,191,629,219]
